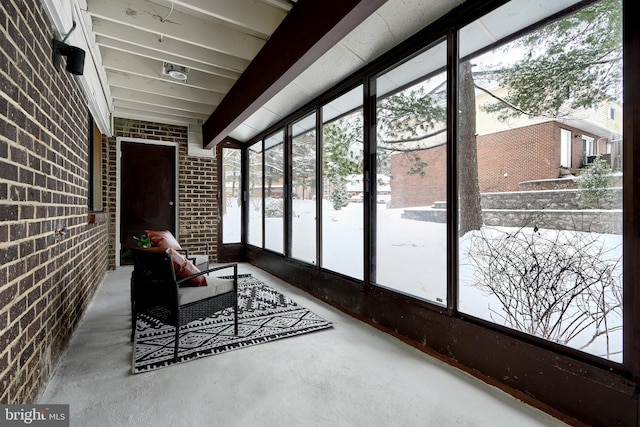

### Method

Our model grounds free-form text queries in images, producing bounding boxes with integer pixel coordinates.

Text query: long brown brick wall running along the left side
[0,0,107,404]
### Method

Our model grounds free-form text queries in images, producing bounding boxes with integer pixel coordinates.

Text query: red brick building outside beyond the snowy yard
[390,121,606,208]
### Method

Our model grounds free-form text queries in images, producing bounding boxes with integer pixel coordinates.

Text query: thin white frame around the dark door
[114,136,180,268]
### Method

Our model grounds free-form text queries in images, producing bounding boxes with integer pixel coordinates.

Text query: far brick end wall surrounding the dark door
[104,118,218,267]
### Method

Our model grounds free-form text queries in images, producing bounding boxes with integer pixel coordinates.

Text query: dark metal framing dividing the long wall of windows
[234,0,640,378]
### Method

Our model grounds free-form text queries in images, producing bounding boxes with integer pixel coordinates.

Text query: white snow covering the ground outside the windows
[224,199,622,362]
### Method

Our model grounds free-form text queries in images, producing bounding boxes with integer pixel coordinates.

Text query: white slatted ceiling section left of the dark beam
[86,0,291,128]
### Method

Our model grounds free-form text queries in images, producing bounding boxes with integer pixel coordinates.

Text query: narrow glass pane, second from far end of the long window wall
[263,132,284,253]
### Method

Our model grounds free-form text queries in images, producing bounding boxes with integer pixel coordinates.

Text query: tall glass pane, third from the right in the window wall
[322,86,364,279]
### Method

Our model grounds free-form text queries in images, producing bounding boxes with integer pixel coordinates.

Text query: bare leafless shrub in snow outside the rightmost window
[467,227,622,356]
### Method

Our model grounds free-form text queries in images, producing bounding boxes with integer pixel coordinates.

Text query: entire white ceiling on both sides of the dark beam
[82,0,464,141]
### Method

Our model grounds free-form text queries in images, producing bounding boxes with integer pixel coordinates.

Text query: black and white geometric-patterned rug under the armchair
[132,275,331,374]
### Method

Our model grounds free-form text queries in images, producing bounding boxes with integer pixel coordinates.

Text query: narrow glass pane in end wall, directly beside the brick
[222,148,242,243]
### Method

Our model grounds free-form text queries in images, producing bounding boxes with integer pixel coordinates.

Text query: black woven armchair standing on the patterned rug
[131,249,238,360]
